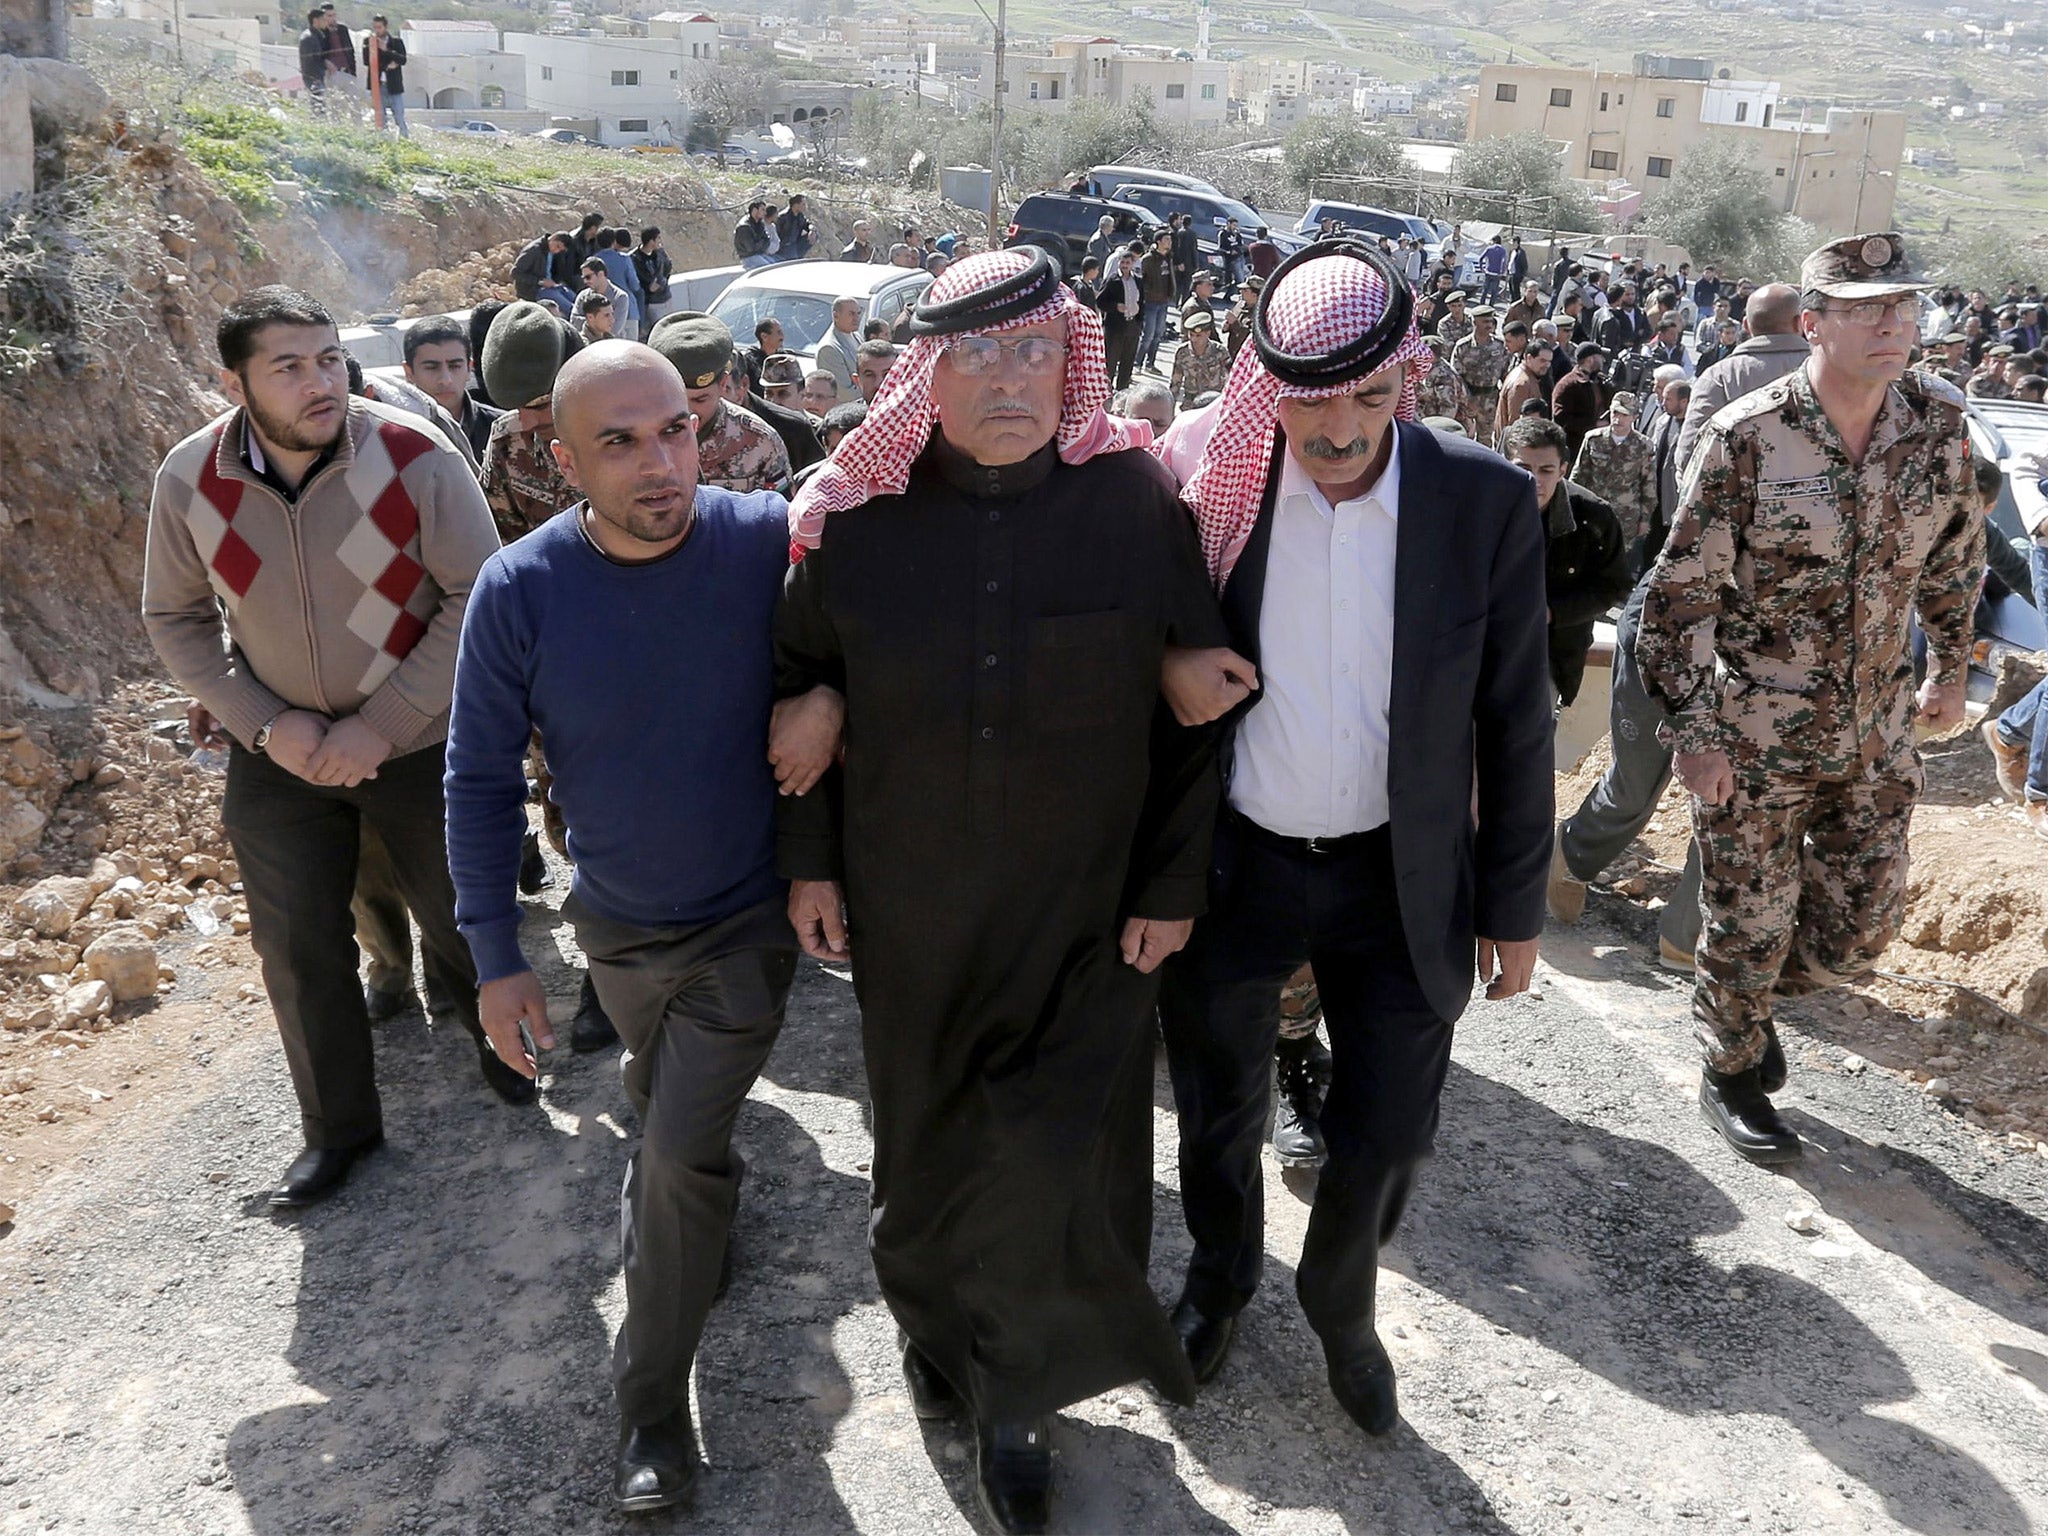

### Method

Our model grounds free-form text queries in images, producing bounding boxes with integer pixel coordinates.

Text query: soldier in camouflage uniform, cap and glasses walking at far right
[1636,233,1982,1163]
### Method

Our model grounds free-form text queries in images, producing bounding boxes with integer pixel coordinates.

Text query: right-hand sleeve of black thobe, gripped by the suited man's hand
[1128,500,1231,922]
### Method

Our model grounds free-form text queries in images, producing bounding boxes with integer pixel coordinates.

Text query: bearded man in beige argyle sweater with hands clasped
[141,287,535,1206]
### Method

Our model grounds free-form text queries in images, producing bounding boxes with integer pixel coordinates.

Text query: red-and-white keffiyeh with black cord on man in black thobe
[788,248,1151,565]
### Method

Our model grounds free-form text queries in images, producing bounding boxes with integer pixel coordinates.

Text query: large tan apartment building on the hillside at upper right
[1466,53,1907,236]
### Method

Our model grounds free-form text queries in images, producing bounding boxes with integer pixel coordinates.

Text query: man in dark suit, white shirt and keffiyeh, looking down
[1159,240,1552,1434]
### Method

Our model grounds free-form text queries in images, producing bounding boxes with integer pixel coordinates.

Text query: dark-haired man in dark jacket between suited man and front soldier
[1501,416,1628,705]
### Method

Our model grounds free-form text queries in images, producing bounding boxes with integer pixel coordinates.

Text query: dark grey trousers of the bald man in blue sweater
[563,895,797,1423]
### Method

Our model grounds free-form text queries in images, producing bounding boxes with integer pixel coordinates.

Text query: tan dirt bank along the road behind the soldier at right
[1556,729,2048,1155]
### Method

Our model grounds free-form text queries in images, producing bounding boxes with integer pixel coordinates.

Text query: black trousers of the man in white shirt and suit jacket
[1159,813,1450,1339]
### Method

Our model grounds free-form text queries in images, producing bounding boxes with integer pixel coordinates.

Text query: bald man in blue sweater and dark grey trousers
[446,342,838,1509]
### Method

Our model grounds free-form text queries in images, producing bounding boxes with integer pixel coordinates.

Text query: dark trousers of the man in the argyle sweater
[221,743,483,1147]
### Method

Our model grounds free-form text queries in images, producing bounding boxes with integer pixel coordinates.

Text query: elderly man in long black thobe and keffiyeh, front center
[776,248,1227,1532]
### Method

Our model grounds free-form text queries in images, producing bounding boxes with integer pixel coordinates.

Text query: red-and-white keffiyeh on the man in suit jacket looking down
[1180,246,1434,592]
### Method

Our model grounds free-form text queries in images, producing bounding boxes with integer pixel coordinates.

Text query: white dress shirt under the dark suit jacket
[1231,432,1401,838]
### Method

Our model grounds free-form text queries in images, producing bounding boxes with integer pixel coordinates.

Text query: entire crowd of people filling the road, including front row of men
[143,197,2048,1532]
